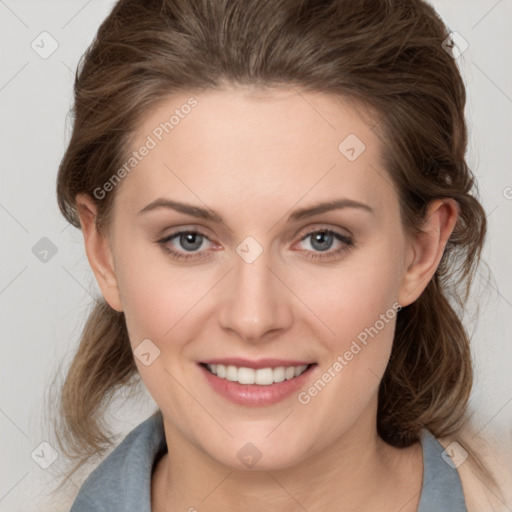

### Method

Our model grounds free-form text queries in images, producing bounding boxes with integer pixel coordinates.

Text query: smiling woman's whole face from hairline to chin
[84,88,432,469]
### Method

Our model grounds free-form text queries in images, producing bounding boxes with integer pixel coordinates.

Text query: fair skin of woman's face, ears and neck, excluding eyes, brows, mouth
[77,87,457,512]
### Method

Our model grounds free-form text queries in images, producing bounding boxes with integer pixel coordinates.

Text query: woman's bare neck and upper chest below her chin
[153,408,422,512]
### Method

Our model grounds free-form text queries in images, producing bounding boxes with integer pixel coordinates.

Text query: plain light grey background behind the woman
[0,0,512,512]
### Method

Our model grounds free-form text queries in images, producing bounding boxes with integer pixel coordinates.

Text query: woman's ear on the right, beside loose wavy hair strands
[398,198,459,306]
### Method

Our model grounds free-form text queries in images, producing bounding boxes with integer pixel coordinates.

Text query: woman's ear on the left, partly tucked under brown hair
[76,194,123,311]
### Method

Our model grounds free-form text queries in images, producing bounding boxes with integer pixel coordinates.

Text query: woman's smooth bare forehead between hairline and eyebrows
[116,87,397,222]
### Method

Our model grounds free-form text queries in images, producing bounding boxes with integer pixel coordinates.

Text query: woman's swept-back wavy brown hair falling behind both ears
[50,0,486,492]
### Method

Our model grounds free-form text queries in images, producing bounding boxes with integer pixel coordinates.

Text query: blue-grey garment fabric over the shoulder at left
[70,411,166,512]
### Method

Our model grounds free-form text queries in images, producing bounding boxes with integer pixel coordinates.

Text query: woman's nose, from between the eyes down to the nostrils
[218,245,293,343]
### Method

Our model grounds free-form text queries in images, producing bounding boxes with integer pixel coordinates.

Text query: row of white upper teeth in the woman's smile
[206,364,308,386]
